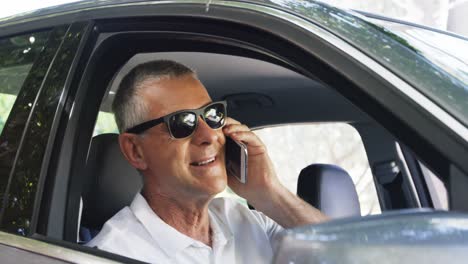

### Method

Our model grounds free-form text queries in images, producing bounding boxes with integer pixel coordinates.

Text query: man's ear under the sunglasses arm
[119,133,148,170]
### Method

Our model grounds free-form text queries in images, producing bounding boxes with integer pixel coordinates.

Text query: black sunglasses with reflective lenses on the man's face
[126,101,227,139]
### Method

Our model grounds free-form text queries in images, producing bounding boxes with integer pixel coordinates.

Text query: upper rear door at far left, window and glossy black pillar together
[0,23,86,236]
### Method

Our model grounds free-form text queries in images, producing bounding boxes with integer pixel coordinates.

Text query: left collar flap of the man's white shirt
[130,193,195,257]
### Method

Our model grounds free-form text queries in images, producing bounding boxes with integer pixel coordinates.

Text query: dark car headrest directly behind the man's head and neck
[81,134,143,229]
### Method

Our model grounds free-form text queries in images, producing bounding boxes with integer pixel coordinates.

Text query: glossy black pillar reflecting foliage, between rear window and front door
[0,22,87,235]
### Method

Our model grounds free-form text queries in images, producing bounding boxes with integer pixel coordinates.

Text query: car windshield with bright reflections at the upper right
[270,0,468,126]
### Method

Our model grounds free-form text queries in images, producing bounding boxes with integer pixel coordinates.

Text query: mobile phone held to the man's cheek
[226,137,248,183]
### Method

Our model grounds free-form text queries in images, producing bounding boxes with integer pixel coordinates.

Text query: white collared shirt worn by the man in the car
[87,193,283,264]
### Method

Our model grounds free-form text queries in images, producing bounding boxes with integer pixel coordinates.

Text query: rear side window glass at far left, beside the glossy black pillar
[0,31,50,234]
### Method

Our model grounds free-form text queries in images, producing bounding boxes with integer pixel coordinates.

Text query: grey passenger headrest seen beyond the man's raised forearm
[297,164,361,218]
